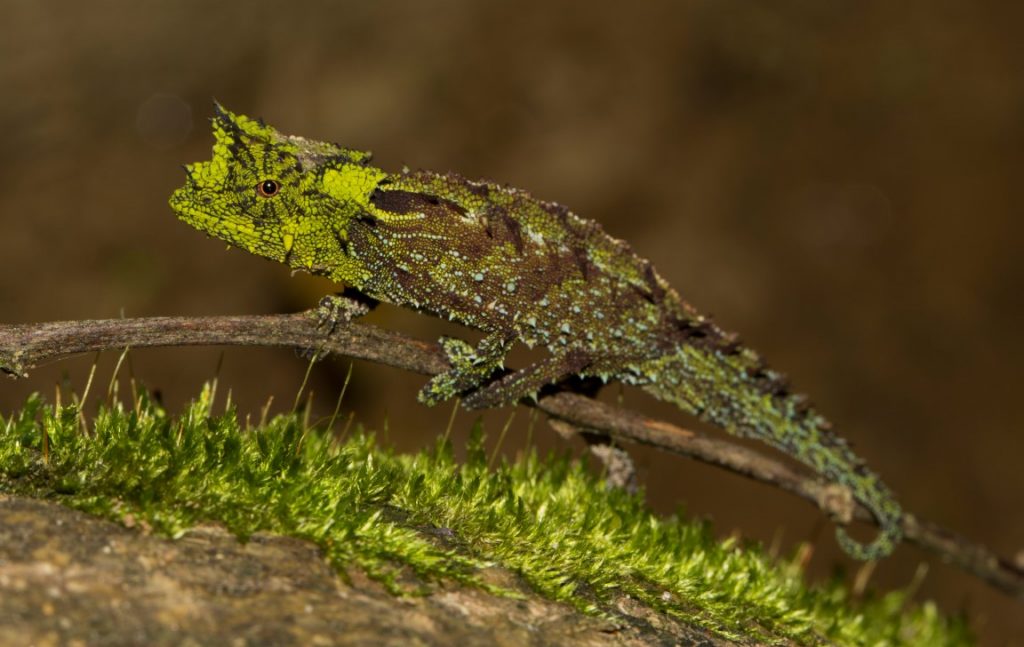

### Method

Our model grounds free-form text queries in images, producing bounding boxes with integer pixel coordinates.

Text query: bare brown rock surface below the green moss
[0,494,724,646]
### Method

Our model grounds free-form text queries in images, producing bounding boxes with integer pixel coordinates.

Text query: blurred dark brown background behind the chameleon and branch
[0,0,1024,644]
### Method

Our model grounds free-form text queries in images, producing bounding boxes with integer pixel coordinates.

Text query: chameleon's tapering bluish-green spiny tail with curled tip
[634,343,903,560]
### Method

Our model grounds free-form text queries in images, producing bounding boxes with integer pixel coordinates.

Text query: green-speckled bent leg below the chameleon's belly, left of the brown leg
[417,334,511,406]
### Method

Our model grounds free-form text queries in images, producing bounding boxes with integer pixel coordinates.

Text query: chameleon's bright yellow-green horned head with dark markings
[170,103,382,271]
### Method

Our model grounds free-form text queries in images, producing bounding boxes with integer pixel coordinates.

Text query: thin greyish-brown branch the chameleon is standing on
[0,310,1024,599]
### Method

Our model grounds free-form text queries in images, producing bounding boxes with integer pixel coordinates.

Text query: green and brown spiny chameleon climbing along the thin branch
[170,102,903,560]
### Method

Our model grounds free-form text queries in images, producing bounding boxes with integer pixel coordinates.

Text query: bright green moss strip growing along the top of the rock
[0,388,971,645]
